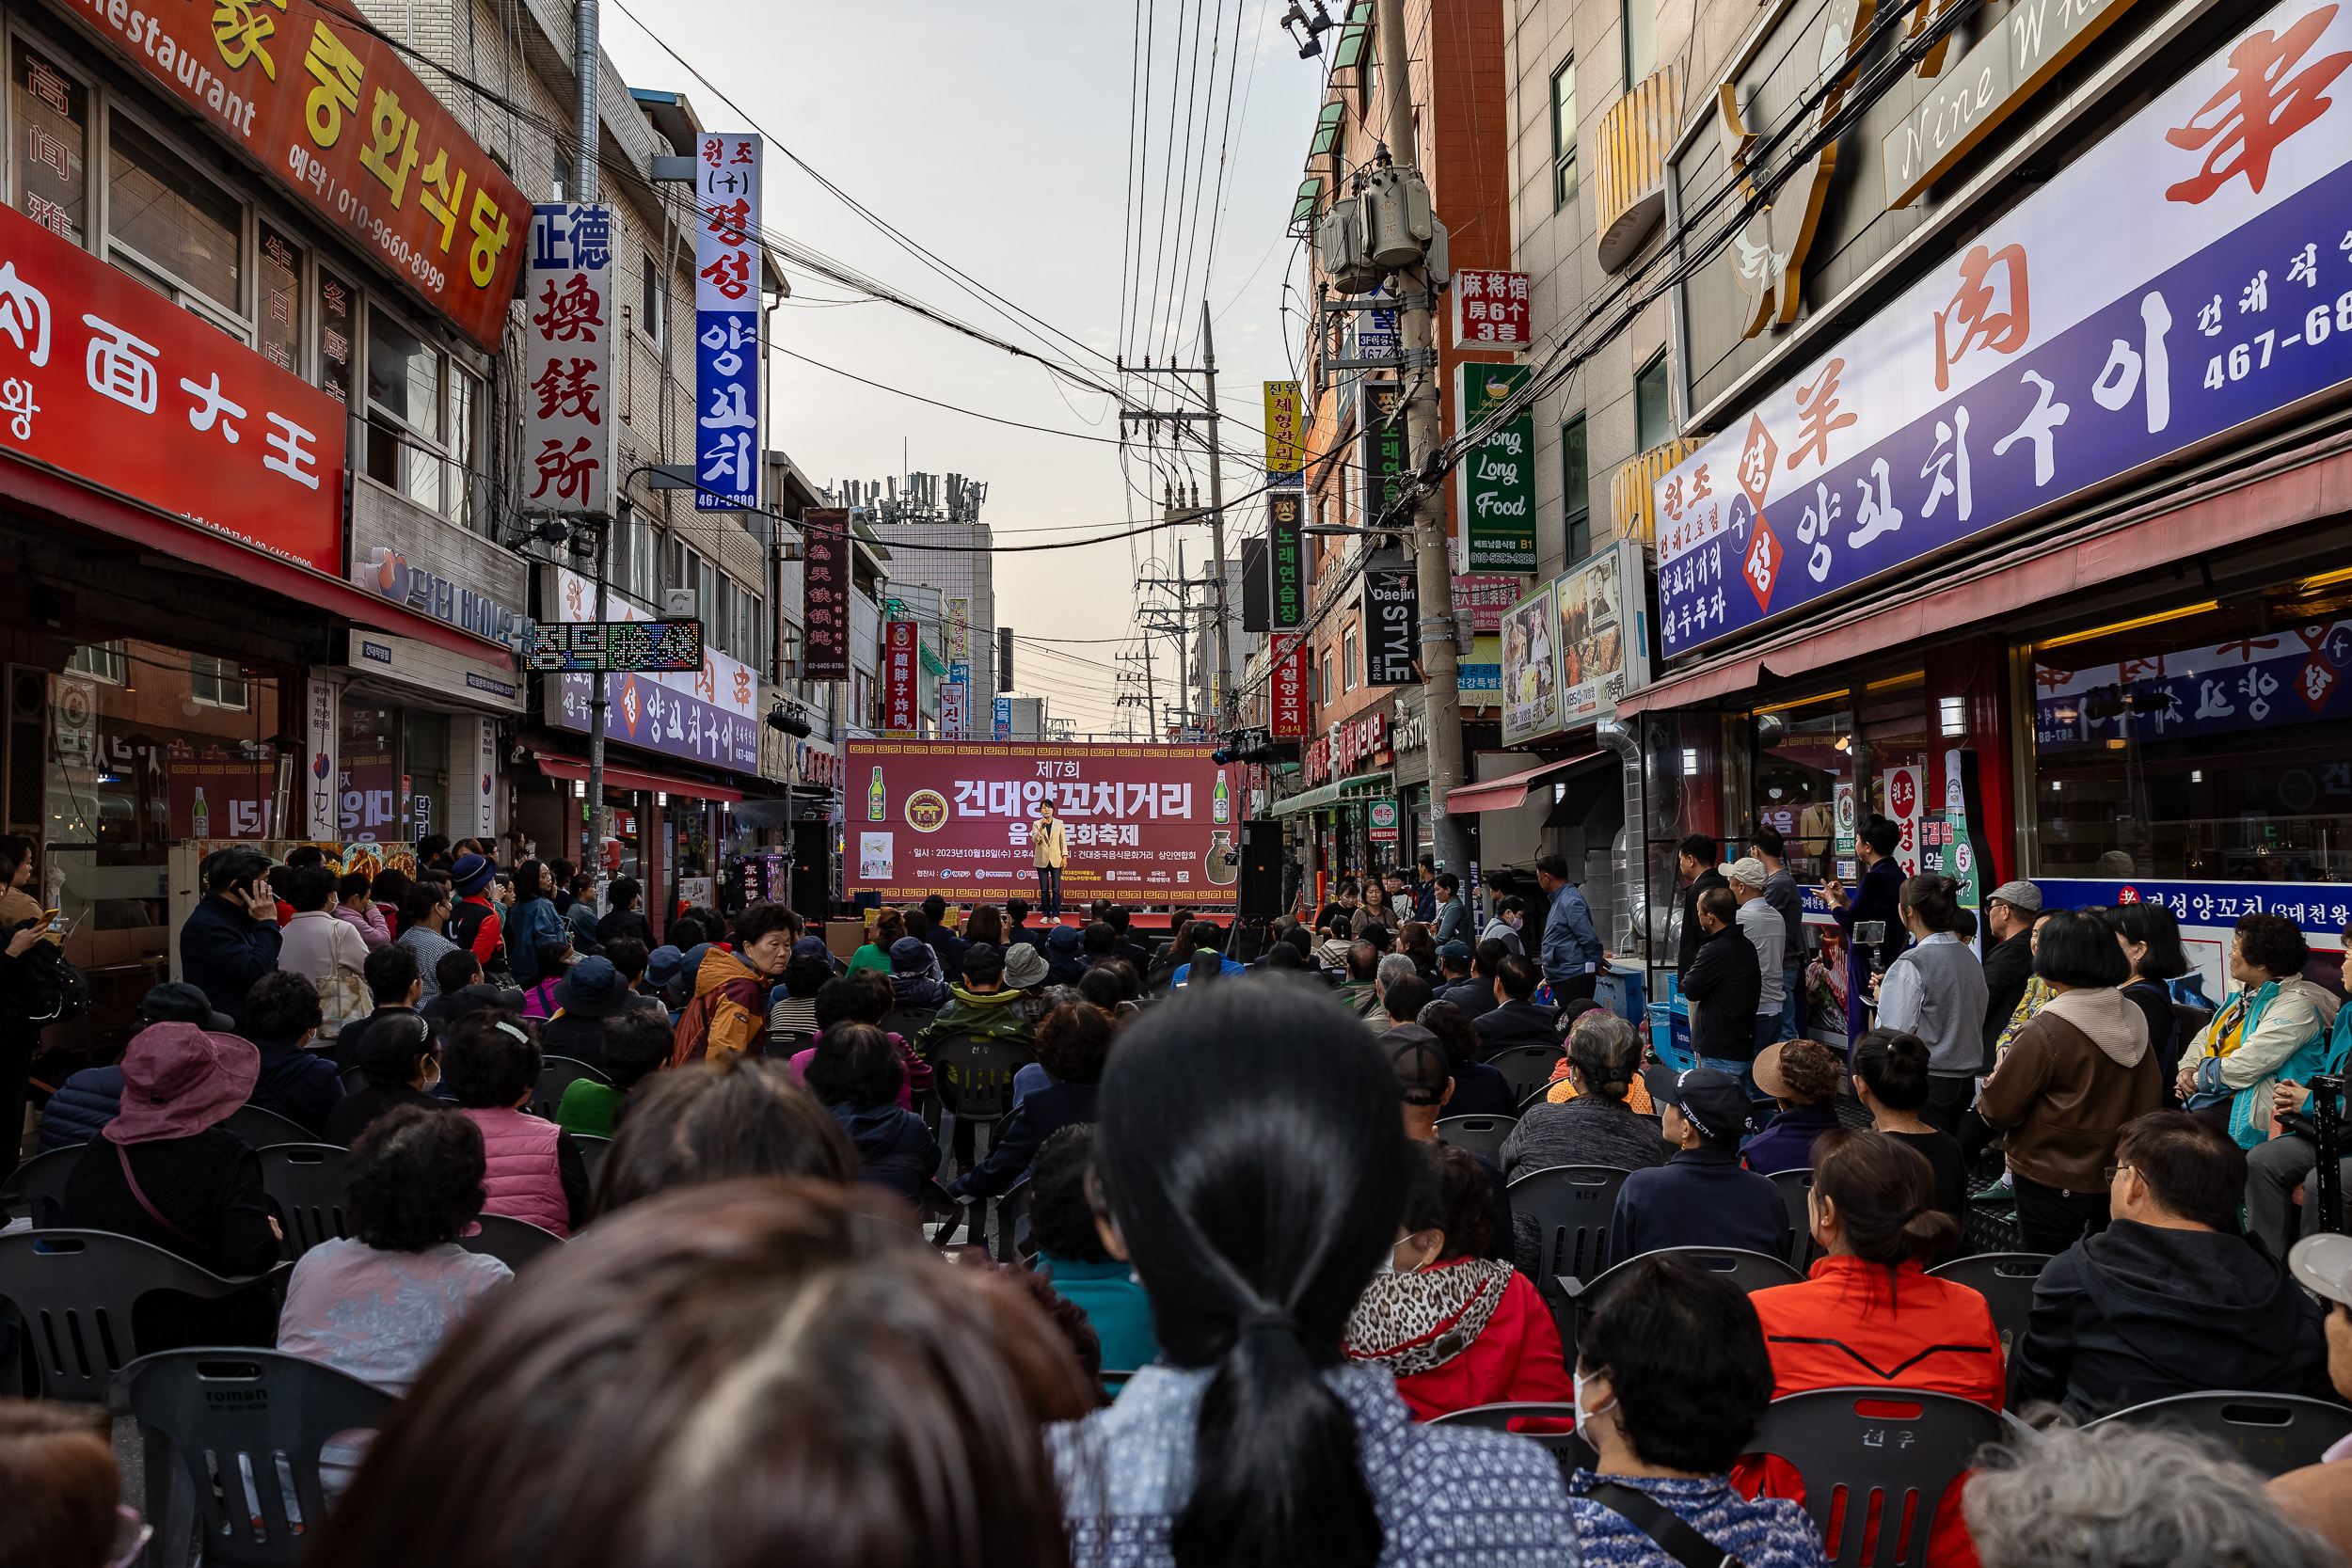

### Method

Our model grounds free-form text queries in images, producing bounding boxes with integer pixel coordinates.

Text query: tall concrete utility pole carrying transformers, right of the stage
[1378,0,1470,875]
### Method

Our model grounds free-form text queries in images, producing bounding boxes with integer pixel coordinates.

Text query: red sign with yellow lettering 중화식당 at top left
[73,0,532,353]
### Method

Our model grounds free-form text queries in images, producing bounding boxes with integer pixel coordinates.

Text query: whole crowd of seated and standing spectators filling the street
[13,825,2352,1568]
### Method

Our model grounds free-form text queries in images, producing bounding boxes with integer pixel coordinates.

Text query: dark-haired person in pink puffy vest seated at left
[442,1013,588,1237]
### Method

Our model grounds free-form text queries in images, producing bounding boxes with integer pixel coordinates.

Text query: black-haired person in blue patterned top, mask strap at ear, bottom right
[1569,1258,1828,1568]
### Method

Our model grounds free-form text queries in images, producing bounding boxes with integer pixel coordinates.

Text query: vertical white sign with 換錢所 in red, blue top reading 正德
[522,202,616,517]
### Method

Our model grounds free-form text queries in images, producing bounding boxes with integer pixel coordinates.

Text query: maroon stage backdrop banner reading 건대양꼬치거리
[847,740,1237,905]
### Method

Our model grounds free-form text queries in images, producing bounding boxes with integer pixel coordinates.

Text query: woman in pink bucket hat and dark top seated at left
[64,1022,280,1350]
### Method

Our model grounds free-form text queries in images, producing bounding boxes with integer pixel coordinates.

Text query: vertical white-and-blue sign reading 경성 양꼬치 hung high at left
[694,132,760,513]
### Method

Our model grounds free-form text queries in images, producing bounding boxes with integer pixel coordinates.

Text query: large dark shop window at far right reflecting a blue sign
[2021,582,2352,884]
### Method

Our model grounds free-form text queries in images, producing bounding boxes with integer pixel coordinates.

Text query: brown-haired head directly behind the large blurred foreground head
[596,1055,859,1215]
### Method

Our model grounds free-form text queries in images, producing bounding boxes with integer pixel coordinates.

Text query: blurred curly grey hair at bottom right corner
[1962,1422,2343,1568]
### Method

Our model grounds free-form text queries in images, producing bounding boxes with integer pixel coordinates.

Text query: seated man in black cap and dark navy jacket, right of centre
[1609,1067,1792,1262]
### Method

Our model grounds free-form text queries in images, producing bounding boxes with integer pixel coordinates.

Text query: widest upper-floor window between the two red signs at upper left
[106,110,245,336]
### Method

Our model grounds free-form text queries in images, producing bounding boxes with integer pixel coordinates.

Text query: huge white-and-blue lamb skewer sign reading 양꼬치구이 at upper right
[1654,0,2352,658]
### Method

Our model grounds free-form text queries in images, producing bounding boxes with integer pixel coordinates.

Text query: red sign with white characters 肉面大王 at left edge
[0,195,343,563]
